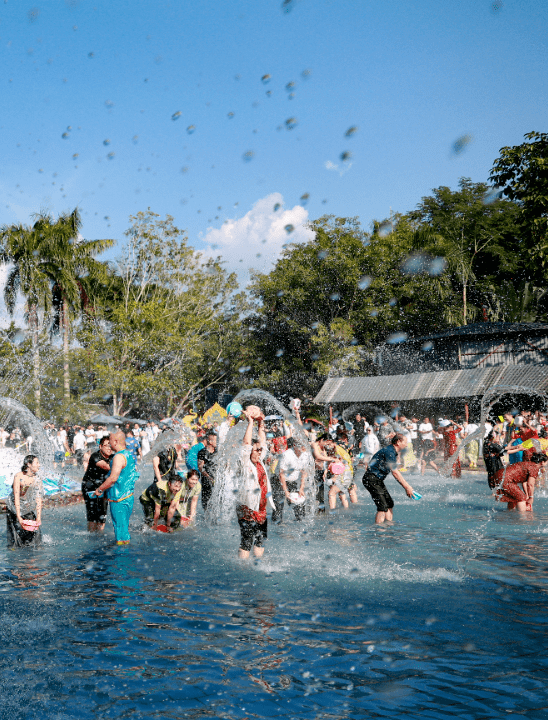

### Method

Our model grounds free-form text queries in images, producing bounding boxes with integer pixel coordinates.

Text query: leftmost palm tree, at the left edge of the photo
[0,218,52,417]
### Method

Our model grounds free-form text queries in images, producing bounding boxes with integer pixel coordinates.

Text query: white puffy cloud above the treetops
[203,193,314,282]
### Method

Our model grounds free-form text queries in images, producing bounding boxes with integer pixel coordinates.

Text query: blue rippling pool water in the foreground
[0,475,548,720]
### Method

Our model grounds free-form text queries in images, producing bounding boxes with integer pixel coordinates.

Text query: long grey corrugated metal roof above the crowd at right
[315,365,548,403]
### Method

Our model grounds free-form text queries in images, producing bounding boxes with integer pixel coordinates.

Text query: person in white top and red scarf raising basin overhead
[236,408,276,559]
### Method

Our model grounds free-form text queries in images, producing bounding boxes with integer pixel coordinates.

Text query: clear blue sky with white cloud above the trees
[0,0,548,281]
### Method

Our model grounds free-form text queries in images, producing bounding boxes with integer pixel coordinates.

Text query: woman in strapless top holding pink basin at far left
[6,455,42,548]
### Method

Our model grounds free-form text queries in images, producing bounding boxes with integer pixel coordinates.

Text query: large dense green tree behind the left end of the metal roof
[248,216,452,394]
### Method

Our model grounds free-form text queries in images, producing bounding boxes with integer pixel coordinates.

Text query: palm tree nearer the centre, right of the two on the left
[36,208,114,406]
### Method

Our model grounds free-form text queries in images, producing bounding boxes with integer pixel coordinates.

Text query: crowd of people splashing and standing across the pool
[5,403,548,558]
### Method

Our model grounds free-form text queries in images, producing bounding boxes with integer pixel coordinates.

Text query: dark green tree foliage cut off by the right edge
[490,132,548,272]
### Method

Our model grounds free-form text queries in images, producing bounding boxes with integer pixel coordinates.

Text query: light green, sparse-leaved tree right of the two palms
[77,209,239,415]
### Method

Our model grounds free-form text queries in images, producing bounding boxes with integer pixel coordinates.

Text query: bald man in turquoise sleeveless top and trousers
[95,430,138,545]
